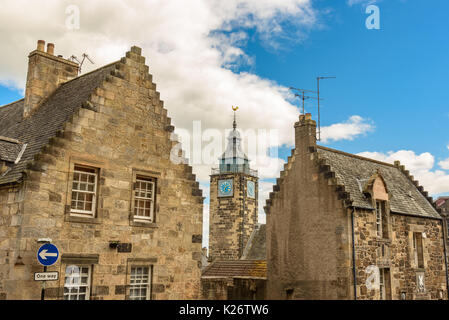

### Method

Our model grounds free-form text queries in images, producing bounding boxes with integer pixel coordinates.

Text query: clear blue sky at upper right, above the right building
[247,0,449,198]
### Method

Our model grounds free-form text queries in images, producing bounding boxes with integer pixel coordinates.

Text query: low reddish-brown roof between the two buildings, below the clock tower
[202,260,267,278]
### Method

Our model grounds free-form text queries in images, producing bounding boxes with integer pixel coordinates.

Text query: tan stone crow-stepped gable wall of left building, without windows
[0,47,203,299]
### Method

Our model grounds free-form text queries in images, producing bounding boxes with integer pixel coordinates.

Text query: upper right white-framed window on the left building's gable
[134,176,156,221]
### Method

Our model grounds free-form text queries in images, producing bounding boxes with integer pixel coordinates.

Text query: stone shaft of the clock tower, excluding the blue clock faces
[209,173,258,260]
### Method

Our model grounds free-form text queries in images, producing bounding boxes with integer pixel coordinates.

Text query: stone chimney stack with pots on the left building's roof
[23,40,79,117]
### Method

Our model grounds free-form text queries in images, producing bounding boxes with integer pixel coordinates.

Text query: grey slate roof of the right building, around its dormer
[317,146,440,218]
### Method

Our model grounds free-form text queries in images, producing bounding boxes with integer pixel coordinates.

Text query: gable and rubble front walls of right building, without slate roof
[265,115,447,299]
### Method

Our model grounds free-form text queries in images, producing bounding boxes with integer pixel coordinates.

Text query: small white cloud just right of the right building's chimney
[321,115,374,143]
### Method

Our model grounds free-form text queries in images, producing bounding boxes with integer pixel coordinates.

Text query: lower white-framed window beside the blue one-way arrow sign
[64,265,91,300]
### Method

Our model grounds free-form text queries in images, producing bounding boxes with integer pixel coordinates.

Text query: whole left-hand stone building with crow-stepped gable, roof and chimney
[0,41,203,299]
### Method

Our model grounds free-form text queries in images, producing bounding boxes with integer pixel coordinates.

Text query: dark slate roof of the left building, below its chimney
[0,62,116,185]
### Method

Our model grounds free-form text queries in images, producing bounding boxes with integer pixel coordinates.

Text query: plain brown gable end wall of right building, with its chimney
[266,117,352,299]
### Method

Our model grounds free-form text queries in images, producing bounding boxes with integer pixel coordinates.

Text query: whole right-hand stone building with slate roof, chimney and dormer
[265,114,448,299]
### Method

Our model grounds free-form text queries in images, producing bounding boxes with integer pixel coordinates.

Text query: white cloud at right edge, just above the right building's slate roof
[358,150,449,195]
